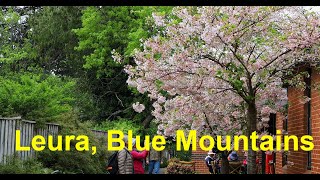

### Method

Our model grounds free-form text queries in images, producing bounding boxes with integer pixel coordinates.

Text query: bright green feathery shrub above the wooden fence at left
[0,73,75,124]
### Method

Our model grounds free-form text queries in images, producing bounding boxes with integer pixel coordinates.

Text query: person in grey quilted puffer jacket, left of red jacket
[118,136,134,174]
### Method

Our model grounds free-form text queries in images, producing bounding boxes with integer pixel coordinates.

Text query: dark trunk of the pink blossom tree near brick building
[247,100,257,174]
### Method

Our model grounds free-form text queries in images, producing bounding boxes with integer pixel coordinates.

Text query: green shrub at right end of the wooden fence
[38,113,110,174]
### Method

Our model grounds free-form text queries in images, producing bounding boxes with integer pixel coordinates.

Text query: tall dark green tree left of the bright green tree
[24,6,98,120]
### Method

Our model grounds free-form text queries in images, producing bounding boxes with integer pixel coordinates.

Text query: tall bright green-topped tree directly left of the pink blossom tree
[74,7,172,131]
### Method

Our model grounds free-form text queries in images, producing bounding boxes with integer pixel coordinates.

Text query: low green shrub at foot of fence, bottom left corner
[0,156,52,174]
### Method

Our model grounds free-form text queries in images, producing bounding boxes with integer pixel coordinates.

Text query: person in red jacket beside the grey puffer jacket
[131,139,148,174]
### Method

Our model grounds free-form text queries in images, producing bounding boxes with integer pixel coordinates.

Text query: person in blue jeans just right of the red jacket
[147,143,162,174]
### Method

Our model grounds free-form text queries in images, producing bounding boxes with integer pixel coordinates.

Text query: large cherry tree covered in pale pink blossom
[120,6,320,173]
